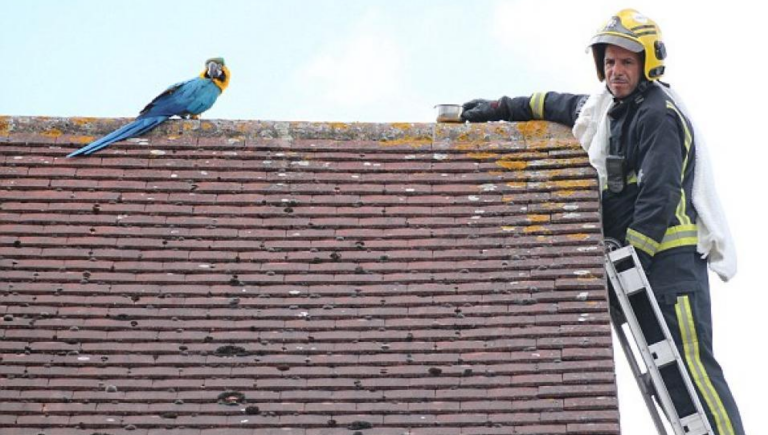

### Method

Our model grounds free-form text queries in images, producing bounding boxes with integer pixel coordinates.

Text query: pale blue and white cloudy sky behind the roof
[0,0,768,435]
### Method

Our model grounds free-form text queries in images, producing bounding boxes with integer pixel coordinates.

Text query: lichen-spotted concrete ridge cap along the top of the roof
[0,116,573,144]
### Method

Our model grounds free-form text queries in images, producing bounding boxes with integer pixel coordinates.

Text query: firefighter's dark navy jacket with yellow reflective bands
[492,82,706,290]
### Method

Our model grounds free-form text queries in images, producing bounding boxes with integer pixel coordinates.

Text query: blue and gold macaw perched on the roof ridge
[67,57,229,157]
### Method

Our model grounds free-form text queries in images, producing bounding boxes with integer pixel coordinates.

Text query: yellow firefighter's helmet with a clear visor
[589,9,667,81]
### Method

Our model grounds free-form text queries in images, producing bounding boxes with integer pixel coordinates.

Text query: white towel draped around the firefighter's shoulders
[573,83,736,281]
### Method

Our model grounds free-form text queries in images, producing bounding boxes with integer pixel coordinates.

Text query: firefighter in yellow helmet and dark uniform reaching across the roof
[462,9,744,435]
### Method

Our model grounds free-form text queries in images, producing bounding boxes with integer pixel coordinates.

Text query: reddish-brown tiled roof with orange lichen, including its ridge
[0,117,619,435]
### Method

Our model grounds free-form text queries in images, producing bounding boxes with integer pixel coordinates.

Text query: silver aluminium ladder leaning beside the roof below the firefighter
[605,244,714,435]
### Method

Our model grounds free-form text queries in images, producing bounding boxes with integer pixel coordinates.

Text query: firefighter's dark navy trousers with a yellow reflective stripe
[611,251,744,435]
